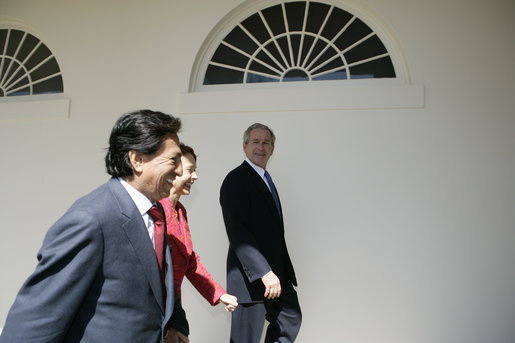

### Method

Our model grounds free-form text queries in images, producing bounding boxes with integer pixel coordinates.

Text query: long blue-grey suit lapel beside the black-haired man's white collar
[109,179,165,313]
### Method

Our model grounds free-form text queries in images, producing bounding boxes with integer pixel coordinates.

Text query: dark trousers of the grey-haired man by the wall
[231,289,302,343]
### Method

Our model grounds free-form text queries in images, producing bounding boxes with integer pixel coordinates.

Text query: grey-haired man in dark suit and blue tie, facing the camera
[220,123,302,343]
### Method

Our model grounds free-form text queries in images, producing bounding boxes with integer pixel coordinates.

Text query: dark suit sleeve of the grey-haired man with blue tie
[220,174,272,282]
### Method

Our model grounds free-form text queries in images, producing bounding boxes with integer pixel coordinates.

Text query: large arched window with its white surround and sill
[177,0,424,114]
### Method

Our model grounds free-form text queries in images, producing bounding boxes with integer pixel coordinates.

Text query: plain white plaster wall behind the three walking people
[0,0,515,343]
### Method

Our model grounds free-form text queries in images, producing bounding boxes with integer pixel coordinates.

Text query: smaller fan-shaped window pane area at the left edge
[0,29,63,97]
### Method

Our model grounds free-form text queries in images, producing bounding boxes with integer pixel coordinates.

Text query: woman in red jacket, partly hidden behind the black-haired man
[159,143,238,334]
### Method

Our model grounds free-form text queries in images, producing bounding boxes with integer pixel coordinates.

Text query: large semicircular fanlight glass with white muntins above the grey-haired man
[203,1,396,85]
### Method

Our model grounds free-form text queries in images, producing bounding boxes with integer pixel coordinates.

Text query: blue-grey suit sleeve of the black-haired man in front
[0,211,103,343]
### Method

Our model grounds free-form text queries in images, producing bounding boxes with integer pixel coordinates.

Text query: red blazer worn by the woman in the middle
[159,198,227,305]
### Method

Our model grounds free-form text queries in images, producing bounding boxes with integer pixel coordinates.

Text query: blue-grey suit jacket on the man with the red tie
[0,179,189,343]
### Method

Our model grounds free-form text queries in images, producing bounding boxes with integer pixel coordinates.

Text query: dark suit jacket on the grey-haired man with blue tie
[220,161,297,303]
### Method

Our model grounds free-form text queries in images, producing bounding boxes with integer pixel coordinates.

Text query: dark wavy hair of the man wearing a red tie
[105,110,181,177]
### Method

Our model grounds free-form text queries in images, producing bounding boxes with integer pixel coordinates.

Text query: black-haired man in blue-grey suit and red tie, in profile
[0,110,188,343]
